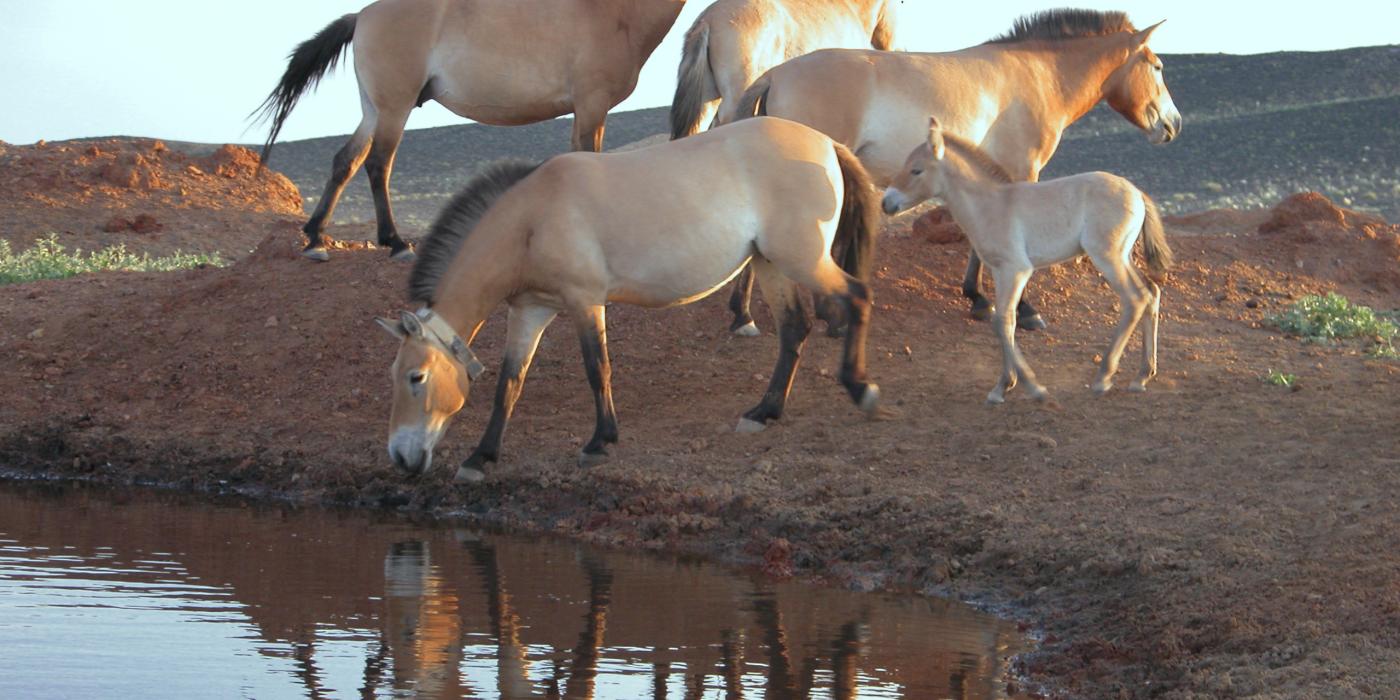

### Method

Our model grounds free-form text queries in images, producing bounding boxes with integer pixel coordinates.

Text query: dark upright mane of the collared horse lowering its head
[409,158,540,304]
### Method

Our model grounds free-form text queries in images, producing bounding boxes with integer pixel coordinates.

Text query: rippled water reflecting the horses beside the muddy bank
[0,484,1021,699]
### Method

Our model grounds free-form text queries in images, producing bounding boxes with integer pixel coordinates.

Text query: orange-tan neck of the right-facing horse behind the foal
[1012,34,1133,130]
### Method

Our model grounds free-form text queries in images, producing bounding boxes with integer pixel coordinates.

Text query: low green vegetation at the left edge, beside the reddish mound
[0,234,224,284]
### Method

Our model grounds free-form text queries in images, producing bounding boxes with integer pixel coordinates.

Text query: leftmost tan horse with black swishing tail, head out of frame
[260,0,686,260]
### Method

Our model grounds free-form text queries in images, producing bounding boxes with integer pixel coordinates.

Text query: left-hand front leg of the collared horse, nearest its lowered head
[452,304,559,483]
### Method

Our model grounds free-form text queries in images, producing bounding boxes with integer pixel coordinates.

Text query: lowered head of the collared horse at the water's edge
[375,309,483,473]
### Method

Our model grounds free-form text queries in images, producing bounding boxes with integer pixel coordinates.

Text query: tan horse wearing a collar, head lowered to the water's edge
[379,119,879,482]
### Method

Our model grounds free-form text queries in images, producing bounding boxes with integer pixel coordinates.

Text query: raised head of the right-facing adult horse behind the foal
[1103,22,1182,144]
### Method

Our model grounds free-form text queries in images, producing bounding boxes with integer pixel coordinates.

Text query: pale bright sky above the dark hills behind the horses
[0,0,1400,143]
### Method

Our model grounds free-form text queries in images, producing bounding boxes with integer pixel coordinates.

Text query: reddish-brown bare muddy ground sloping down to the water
[0,140,1400,697]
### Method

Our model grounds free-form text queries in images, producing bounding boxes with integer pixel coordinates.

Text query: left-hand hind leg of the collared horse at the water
[736,256,812,433]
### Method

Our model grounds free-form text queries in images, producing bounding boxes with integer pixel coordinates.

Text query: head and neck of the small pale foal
[881,116,1012,214]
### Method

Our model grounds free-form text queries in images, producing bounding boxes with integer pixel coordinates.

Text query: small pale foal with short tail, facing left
[882,118,1172,403]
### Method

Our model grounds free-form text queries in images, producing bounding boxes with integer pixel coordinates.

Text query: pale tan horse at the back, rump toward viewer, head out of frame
[671,0,897,139]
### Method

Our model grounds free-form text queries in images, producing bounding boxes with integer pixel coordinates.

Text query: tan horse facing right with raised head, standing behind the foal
[729,10,1182,335]
